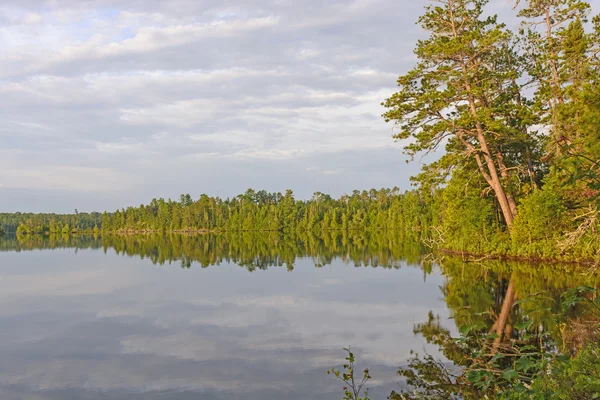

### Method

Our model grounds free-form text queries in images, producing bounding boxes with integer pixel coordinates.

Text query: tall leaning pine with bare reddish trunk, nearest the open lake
[384,0,536,228]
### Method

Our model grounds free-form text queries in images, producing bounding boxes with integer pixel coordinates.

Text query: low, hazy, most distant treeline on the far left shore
[0,210,102,235]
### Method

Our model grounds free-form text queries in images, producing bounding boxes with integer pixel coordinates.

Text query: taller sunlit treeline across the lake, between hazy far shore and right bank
[102,189,431,236]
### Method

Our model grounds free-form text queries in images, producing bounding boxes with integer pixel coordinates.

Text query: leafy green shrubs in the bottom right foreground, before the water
[390,278,600,400]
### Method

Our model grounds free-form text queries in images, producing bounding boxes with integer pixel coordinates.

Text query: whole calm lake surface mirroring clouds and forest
[0,233,591,400]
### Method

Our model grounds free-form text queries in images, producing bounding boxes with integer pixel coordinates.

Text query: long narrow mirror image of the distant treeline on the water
[0,231,423,270]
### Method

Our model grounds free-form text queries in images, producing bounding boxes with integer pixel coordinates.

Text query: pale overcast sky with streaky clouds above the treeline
[0,0,510,212]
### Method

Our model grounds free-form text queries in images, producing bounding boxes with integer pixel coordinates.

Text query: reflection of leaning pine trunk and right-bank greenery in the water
[441,258,597,356]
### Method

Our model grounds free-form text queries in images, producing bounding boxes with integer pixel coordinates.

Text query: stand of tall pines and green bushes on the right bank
[376,0,600,263]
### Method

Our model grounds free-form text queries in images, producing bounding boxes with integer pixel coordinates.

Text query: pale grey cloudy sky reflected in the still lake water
[0,247,446,399]
